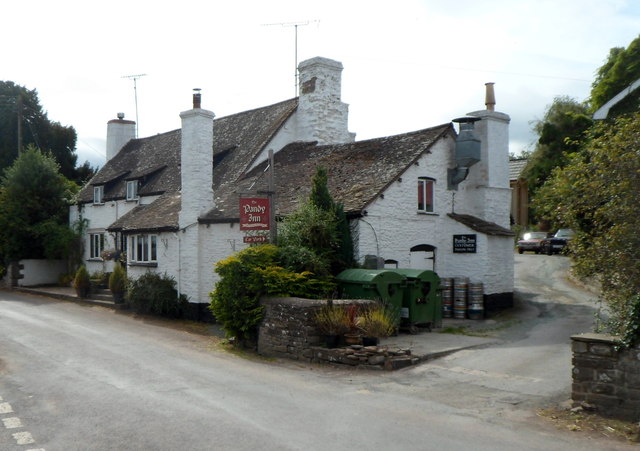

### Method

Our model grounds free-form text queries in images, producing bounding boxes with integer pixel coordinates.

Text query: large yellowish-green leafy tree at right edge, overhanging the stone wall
[534,113,640,342]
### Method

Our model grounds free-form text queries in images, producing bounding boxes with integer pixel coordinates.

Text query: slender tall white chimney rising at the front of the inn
[178,90,215,228]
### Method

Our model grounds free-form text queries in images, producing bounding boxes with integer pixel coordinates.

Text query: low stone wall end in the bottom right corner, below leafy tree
[571,334,640,421]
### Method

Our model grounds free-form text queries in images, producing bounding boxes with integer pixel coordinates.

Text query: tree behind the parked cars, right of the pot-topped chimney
[522,96,593,203]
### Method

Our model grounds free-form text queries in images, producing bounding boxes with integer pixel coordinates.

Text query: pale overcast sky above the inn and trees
[0,0,640,170]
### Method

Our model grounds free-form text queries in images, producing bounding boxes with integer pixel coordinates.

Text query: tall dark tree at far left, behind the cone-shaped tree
[0,81,90,182]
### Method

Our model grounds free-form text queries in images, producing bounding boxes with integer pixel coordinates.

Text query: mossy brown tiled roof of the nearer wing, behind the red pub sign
[200,124,455,222]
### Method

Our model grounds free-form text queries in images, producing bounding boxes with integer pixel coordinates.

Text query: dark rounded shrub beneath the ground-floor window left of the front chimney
[127,272,188,318]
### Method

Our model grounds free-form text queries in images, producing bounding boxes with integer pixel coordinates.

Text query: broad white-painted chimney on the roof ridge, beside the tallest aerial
[296,57,355,144]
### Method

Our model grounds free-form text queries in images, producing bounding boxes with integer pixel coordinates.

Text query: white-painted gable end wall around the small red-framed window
[355,132,513,294]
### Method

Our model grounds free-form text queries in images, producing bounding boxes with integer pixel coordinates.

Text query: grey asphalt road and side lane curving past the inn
[0,255,631,451]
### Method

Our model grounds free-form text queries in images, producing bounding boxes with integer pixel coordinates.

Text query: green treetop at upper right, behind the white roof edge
[589,36,640,119]
